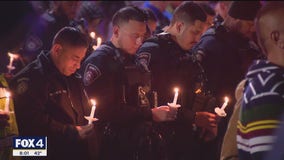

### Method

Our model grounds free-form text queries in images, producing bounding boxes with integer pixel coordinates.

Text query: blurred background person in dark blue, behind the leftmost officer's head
[19,1,81,63]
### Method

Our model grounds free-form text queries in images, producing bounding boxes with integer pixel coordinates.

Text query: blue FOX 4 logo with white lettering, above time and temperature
[13,137,47,149]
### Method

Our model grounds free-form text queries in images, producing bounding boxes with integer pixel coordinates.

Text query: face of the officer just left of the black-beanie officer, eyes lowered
[176,20,205,50]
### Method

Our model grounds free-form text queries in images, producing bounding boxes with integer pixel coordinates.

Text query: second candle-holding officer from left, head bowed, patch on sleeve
[81,6,174,160]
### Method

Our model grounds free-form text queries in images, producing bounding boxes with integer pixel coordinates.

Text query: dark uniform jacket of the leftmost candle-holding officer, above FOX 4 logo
[10,52,90,159]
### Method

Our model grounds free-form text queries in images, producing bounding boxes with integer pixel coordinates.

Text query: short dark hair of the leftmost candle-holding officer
[52,27,89,48]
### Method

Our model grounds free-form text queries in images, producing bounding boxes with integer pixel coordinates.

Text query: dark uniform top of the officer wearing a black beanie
[193,25,260,104]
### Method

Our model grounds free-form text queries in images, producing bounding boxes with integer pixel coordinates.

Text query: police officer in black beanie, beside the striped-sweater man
[193,1,260,159]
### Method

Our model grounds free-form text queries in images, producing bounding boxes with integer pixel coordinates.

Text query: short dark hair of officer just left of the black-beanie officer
[171,2,207,24]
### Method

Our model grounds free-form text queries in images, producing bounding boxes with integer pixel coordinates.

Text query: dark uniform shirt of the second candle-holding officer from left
[80,42,152,125]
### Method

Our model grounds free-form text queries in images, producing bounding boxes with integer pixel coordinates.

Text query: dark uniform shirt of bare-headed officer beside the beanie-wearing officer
[137,33,199,126]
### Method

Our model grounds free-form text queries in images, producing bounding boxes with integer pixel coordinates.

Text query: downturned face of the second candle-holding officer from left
[117,20,146,54]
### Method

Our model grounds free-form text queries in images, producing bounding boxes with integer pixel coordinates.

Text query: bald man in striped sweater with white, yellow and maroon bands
[237,2,284,160]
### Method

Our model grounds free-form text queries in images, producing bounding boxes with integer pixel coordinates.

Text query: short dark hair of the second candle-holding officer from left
[112,5,148,26]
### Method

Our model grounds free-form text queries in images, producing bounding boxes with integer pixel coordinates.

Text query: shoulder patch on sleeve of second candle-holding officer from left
[83,63,101,86]
